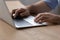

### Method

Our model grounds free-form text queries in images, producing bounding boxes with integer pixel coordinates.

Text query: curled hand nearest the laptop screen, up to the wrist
[12,8,30,18]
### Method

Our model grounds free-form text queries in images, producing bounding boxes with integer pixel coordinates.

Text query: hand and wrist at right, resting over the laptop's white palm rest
[34,13,60,24]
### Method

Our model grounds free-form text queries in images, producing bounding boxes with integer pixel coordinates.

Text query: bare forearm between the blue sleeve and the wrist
[27,1,51,14]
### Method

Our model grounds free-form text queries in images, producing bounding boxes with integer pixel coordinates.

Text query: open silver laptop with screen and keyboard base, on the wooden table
[0,0,47,28]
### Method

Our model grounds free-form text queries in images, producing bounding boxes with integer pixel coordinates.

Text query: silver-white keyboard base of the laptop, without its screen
[14,16,47,28]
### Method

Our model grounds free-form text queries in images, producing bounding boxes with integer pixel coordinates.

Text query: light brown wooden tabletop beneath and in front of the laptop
[0,1,60,40]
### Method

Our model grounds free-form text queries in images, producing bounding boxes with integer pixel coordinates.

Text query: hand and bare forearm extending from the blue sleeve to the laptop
[12,1,51,19]
